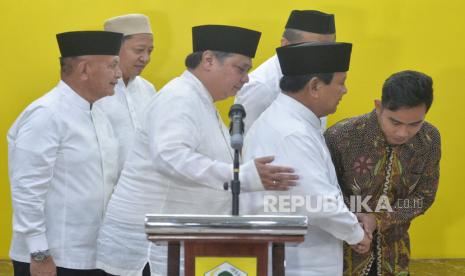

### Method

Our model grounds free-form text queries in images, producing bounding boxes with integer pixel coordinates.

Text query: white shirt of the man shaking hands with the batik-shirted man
[241,94,363,276]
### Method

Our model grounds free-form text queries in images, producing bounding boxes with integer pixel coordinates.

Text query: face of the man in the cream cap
[119,34,153,80]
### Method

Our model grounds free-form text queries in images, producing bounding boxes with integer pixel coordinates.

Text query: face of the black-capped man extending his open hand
[211,54,252,101]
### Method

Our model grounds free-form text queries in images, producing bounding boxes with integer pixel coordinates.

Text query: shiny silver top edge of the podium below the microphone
[145,214,308,236]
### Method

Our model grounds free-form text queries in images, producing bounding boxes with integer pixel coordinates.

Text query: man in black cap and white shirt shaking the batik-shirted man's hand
[242,42,371,276]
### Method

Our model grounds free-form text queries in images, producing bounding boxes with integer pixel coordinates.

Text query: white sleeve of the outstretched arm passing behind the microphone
[147,97,263,190]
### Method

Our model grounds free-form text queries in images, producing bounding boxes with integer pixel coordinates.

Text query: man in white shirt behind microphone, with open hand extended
[98,25,297,276]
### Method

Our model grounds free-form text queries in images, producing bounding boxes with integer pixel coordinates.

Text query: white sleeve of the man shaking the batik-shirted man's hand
[276,134,364,244]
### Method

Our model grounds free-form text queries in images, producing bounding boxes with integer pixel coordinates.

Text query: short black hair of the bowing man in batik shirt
[381,70,433,111]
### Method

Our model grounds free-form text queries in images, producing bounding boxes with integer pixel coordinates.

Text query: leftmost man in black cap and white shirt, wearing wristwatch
[8,31,122,276]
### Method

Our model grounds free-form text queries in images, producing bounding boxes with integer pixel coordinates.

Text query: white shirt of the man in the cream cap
[95,76,157,170]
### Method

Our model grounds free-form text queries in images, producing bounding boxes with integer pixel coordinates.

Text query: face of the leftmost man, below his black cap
[88,55,121,100]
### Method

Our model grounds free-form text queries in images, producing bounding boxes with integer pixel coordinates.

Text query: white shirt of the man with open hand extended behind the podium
[94,71,263,275]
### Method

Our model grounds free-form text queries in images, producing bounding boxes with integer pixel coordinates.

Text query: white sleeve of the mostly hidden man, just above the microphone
[235,79,277,132]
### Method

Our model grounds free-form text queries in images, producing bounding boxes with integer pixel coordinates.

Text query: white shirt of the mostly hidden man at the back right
[235,55,327,132]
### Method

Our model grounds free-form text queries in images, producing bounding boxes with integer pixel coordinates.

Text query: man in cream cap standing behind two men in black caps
[97,14,156,170]
